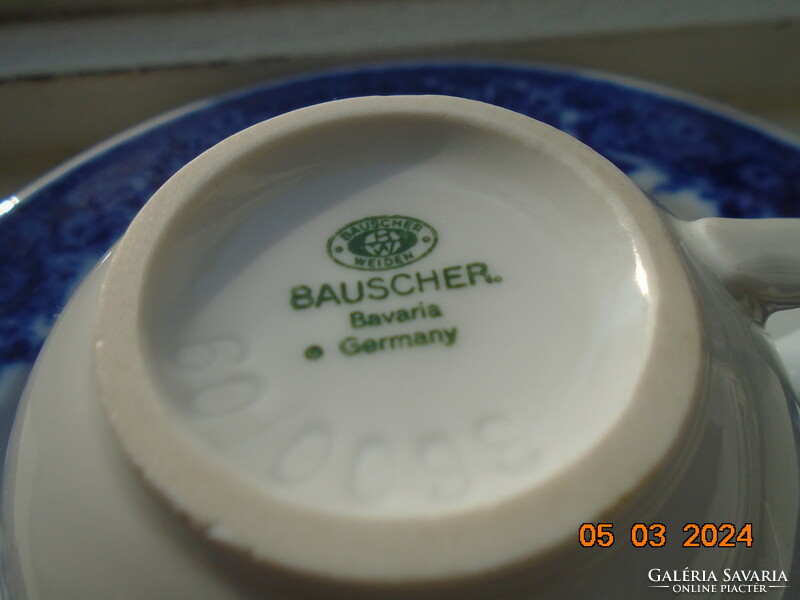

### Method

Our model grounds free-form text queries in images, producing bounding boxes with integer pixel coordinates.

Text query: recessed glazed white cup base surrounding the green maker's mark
[142,117,653,518]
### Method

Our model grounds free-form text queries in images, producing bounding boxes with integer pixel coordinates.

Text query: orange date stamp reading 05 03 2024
[578,523,753,548]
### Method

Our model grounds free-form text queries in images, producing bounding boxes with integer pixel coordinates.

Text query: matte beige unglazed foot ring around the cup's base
[95,96,703,583]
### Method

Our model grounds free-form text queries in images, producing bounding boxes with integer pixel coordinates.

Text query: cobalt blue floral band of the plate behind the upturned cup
[0,64,800,374]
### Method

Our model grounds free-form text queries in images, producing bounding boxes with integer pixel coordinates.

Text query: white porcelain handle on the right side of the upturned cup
[679,217,800,322]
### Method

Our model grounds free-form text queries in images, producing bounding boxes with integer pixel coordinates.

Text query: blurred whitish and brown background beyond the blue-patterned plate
[0,0,800,197]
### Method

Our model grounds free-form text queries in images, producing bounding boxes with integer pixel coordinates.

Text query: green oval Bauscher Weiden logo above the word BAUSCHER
[328,215,438,271]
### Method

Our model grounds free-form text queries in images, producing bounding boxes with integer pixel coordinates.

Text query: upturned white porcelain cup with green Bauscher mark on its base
[4,96,800,600]
